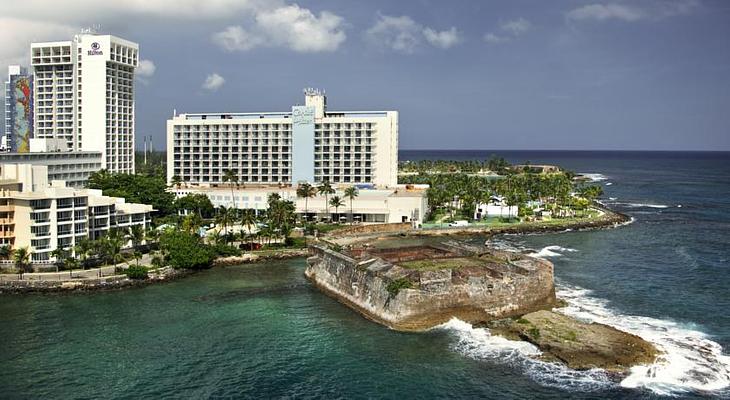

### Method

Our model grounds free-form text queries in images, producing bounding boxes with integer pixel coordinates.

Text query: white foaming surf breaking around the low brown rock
[434,286,730,397]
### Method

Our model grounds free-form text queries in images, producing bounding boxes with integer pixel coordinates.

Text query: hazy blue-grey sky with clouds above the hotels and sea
[0,0,730,151]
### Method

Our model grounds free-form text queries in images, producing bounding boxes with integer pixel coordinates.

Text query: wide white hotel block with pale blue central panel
[167,89,398,187]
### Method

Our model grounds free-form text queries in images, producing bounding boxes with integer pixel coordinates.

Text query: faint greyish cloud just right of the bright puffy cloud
[365,15,462,54]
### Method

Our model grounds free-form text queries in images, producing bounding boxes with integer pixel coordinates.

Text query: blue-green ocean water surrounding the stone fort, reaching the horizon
[0,151,730,399]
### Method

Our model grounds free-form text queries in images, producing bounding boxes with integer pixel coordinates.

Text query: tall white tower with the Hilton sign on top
[30,33,139,173]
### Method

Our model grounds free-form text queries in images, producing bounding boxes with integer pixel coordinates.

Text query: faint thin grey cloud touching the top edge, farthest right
[565,0,700,22]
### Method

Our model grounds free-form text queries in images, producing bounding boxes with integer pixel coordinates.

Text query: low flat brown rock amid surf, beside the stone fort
[486,310,658,373]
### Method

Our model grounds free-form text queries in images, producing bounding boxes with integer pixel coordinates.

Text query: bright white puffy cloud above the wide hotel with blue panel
[212,4,347,53]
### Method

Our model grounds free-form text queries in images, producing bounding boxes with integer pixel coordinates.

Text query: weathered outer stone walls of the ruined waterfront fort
[305,246,555,330]
